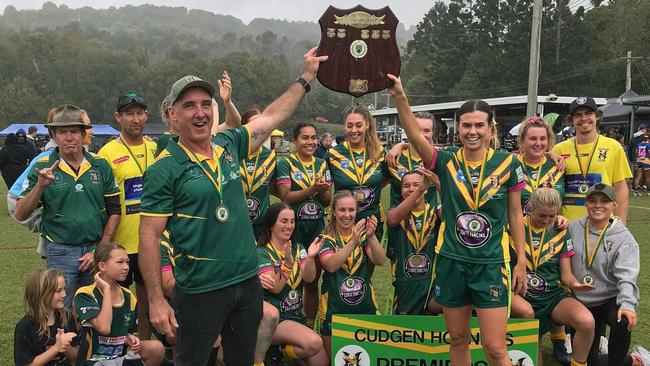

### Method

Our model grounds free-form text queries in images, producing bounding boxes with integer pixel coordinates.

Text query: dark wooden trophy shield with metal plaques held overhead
[317,5,401,98]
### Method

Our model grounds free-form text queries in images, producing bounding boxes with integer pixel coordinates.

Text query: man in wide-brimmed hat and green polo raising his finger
[15,105,120,309]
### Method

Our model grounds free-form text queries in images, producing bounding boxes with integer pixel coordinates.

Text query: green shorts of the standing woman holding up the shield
[433,255,510,309]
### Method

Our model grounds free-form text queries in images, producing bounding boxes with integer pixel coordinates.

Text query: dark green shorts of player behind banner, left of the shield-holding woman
[393,278,431,315]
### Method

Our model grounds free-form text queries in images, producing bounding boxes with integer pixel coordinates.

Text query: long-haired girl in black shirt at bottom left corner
[14,269,77,366]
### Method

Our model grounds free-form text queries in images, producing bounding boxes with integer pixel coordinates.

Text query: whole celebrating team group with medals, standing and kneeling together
[8,49,647,365]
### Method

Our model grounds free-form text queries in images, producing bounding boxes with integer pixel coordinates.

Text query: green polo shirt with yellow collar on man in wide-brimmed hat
[20,148,120,245]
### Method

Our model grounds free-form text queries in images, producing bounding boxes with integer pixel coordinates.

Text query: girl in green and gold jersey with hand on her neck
[74,243,164,365]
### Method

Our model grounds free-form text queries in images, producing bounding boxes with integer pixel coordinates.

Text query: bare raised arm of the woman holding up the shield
[388,74,435,167]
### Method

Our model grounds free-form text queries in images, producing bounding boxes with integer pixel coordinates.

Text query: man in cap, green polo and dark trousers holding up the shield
[139,48,327,366]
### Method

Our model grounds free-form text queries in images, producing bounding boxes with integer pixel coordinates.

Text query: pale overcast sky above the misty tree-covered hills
[0,0,434,27]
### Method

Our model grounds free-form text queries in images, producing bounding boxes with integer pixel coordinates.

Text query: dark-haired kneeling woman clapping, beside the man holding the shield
[257,202,328,365]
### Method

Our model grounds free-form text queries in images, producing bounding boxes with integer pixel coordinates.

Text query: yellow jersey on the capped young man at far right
[553,135,632,221]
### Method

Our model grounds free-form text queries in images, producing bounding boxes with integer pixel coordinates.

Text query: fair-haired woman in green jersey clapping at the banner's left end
[318,190,386,355]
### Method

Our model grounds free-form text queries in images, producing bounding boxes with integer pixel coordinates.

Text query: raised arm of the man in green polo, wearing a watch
[246,47,327,151]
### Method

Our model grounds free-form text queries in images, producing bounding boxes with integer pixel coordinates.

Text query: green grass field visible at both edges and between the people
[0,183,650,366]
